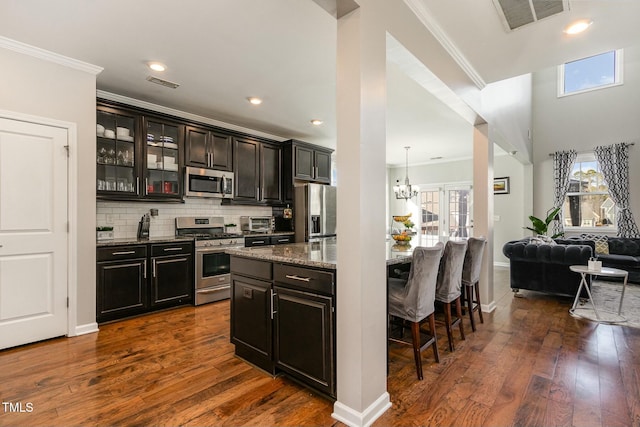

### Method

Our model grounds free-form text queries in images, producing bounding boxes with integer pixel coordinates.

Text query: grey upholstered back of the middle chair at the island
[436,240,467,303]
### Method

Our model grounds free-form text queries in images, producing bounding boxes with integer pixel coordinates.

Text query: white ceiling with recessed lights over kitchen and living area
[0,0,640,165]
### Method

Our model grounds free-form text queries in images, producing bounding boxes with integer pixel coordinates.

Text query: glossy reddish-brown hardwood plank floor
[0,273,640,426]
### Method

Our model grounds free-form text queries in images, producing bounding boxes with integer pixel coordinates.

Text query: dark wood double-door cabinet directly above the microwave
[185,126,233,171]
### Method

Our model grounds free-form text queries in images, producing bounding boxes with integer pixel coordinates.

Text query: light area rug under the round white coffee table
[575,280,640,328]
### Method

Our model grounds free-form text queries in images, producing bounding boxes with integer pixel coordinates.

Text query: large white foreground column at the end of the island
[332,1,391,426]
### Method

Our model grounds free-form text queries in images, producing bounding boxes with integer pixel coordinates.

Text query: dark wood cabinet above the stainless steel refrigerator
[282,139,333,203]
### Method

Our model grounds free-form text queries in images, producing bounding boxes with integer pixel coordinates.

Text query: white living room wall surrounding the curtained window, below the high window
[533,47,640,222]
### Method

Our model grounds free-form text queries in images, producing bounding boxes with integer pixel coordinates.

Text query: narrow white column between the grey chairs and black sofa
[473,123,496,311]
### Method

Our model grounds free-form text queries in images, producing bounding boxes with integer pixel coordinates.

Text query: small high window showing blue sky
[558,49,622,96]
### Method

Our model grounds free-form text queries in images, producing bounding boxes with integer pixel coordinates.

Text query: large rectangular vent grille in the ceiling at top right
[493,0,569,31]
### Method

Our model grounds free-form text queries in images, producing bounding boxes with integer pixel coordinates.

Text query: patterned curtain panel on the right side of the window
[594,142,640,237]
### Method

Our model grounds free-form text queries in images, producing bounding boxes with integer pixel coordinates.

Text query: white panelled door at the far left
[0,118,68,349]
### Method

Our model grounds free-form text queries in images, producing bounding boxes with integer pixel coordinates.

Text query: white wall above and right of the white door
[0,48,96,326]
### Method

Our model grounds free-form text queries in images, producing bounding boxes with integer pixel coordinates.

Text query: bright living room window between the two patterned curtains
[562,154,616,228]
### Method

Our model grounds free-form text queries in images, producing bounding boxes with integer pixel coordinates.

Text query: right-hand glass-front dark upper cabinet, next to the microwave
[144,118,184,198]
